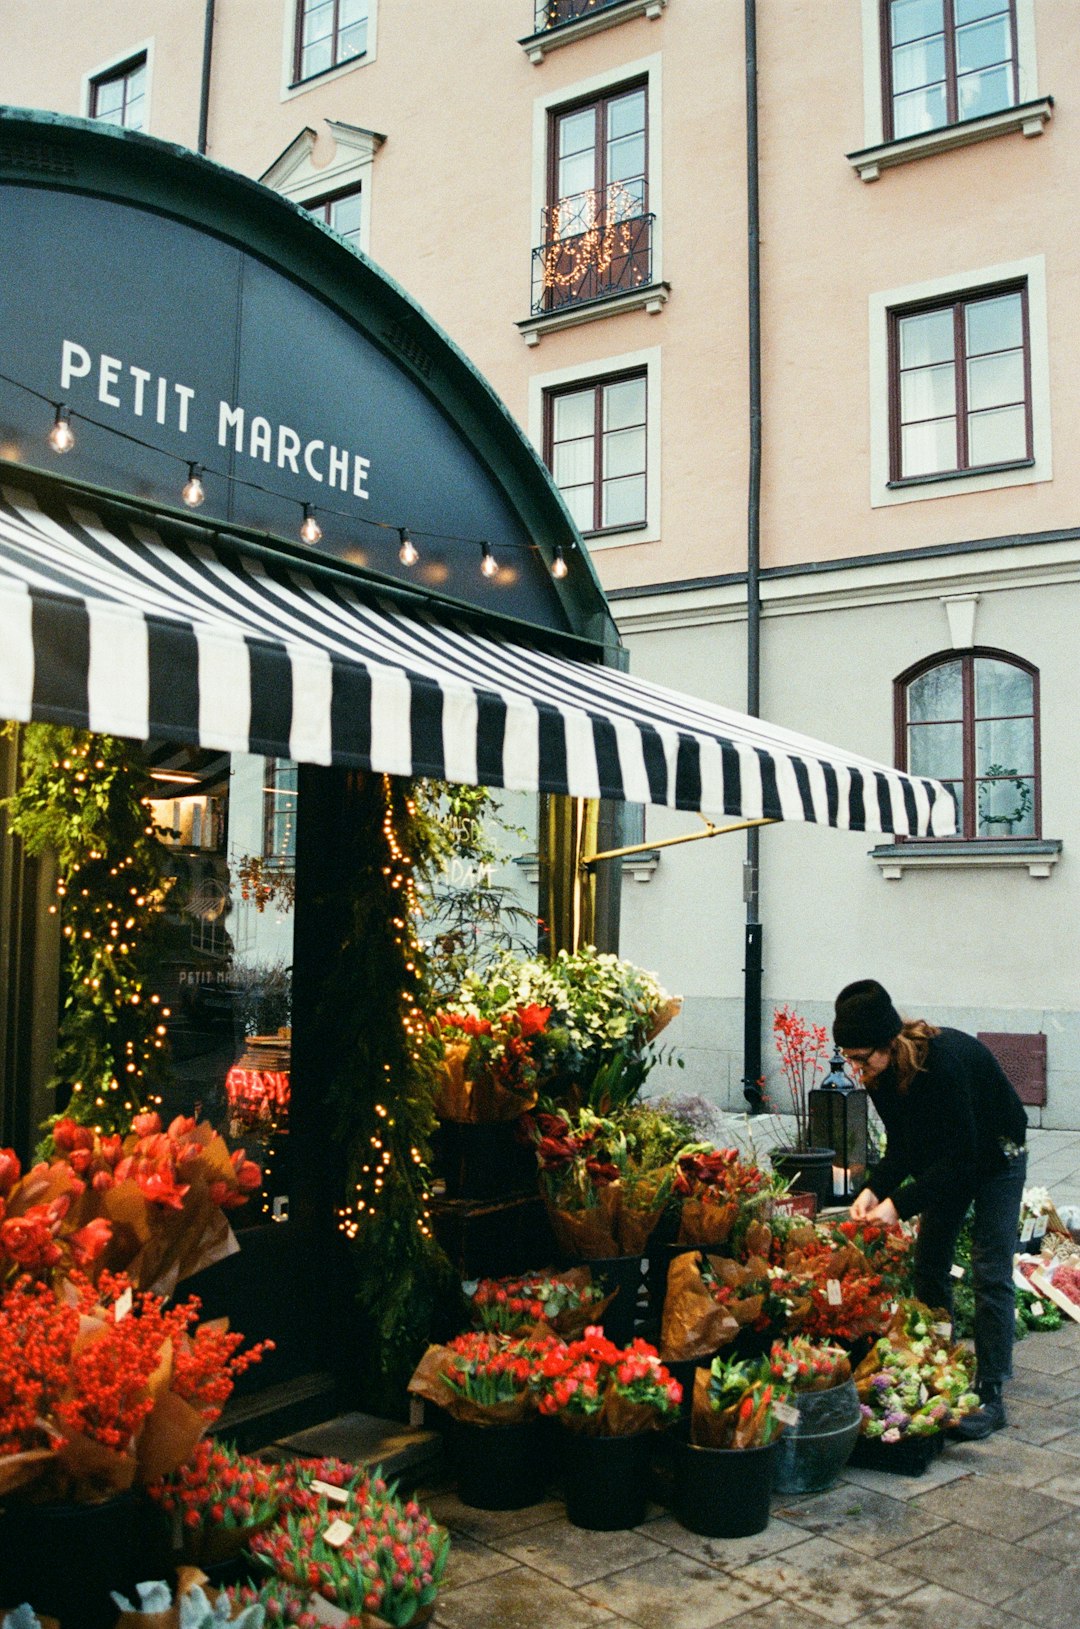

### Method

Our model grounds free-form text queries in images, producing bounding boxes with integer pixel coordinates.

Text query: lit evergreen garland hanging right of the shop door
[329,775,461,1394]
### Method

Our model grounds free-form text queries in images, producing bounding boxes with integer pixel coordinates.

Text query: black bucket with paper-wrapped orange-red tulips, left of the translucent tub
[674,1357,797,1538]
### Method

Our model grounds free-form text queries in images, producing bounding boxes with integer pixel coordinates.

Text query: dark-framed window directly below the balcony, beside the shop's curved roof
[544,368,648,533]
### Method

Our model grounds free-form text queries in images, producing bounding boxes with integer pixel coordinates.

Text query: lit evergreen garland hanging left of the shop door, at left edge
[7,723,169,1134]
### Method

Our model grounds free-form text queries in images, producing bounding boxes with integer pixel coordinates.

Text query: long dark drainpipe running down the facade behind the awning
[743,0,764,1114]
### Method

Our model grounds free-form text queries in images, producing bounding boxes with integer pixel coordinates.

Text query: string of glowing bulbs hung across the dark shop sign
[0,371,577,578]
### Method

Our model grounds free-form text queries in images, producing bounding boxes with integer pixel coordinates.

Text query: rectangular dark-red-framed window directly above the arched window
[889,283,1033,481]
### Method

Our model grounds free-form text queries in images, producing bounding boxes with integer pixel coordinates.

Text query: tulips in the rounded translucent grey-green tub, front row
[769,1336,862,1494]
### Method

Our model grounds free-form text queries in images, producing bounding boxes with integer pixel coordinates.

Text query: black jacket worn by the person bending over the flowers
[867,1030,1028,1218]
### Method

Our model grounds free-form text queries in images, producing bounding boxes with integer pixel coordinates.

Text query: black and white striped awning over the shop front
[0,487,955,836]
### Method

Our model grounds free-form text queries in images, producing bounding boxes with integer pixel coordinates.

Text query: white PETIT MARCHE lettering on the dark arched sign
[60,339,371,502]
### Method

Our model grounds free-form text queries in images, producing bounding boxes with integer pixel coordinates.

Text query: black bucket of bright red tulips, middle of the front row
[534,1328,683,1531]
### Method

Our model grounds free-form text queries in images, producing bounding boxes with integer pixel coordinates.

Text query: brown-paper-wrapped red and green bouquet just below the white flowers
[531,1109,673,1261]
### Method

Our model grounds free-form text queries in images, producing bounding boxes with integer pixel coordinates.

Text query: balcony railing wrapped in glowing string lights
[533,187,656,316]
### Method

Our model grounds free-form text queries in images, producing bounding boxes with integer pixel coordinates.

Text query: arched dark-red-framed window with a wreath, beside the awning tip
[896,648,1041,839]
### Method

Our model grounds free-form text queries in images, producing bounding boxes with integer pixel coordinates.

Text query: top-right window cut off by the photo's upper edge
[881,0,1018,140]
